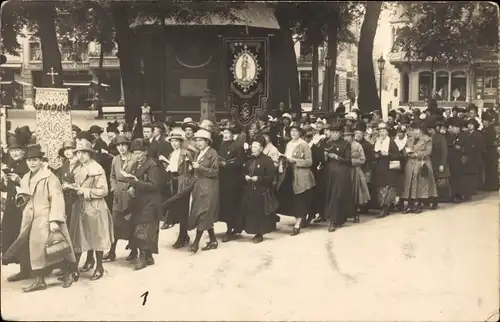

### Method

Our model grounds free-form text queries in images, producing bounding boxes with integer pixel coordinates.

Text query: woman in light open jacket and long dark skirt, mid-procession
[277,125,316,236]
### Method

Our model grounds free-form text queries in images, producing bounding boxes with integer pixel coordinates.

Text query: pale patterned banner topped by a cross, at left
[35,87,72,169]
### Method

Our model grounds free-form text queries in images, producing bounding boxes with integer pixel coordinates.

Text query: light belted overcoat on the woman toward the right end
[401,135,437,199]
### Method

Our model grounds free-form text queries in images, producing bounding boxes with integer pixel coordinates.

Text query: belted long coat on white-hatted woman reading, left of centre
[188,147,219,230]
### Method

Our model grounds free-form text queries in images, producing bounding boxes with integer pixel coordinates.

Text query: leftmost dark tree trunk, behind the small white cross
[35,2,63,88]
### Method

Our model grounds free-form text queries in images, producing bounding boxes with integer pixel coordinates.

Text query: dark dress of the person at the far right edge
[483,126,499,191]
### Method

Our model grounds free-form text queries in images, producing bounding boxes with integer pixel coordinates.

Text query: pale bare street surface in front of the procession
[1,194,499,321]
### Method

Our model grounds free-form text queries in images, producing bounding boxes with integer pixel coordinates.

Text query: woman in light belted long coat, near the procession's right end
[401,121,437,214]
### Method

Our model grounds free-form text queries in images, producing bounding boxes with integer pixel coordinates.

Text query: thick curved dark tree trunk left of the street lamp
[358,1,382,112]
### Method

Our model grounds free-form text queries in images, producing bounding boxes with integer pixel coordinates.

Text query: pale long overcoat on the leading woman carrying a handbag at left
[4,165,76,270]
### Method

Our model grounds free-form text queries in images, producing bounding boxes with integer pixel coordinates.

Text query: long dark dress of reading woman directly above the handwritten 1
[129,159,161,254]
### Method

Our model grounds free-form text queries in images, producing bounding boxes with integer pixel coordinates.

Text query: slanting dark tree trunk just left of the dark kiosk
[111,2,142,132]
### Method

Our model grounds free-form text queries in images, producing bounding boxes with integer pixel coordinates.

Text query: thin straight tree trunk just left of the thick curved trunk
[322,13,339,112]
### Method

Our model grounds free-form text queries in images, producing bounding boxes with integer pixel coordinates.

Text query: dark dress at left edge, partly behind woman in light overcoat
[0,156,29,263]
